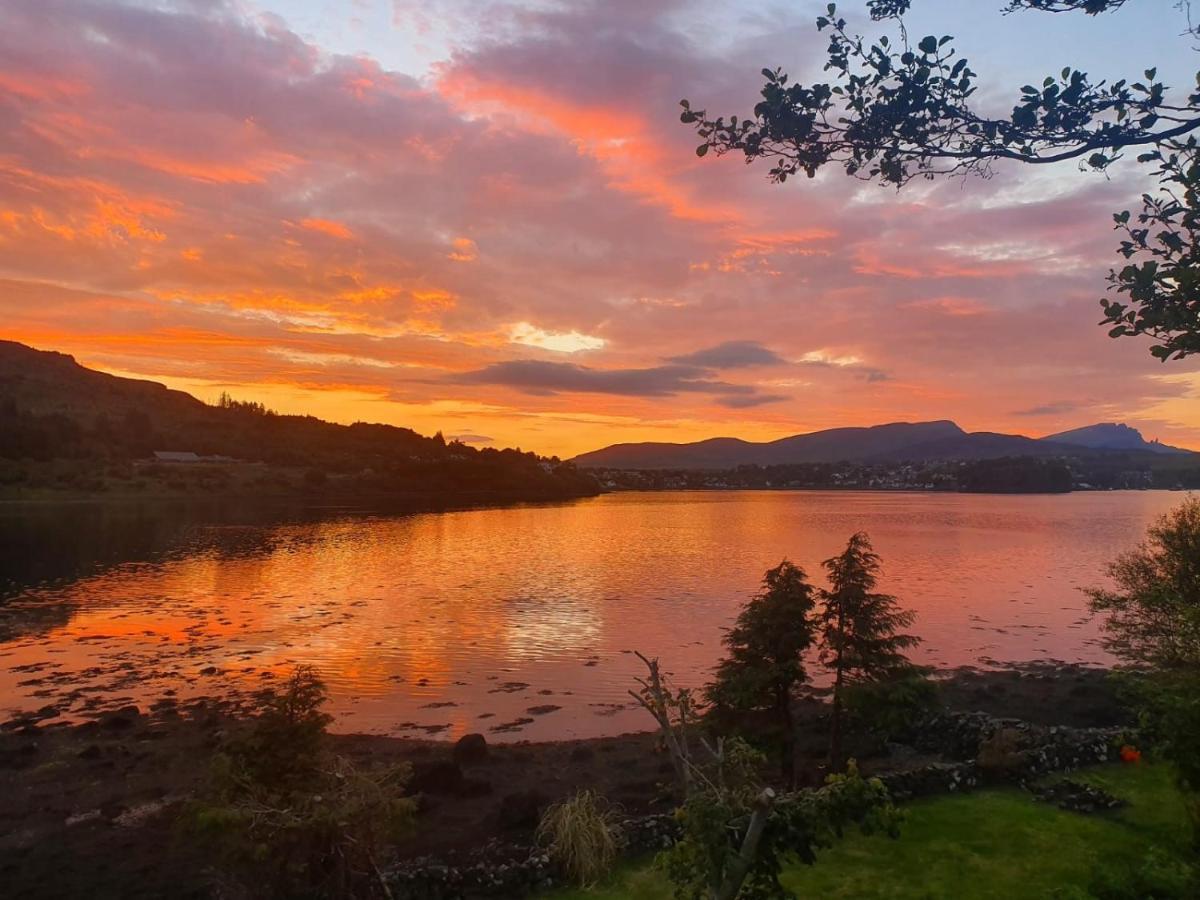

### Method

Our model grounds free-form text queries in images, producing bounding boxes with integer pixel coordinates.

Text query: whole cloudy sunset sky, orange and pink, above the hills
[0,0,1200,456]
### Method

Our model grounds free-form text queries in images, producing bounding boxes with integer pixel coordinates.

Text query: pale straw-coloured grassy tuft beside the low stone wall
[536,791,617,887]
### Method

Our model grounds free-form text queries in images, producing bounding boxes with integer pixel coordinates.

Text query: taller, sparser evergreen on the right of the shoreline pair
[818,532,920,772]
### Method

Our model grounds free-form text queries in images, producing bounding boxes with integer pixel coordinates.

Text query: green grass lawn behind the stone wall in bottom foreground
[550,764,1187,900]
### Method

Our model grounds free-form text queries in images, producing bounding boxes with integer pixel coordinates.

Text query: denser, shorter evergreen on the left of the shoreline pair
[706,559,816,784]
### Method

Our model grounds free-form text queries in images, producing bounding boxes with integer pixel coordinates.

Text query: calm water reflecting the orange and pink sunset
[0,492,1182,739]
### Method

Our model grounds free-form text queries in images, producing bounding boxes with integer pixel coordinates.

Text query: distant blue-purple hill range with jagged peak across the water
[574,420,1189,470]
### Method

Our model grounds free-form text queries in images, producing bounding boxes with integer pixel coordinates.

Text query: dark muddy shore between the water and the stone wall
[0,664,1128,898]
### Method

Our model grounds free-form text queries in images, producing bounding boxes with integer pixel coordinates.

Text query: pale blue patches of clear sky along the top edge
[241,0,1200,92]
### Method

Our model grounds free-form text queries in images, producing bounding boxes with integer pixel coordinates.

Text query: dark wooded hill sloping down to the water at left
[0,341,598,499]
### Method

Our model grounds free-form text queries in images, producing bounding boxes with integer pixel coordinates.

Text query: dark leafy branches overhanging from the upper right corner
[680,0,1200,360]
